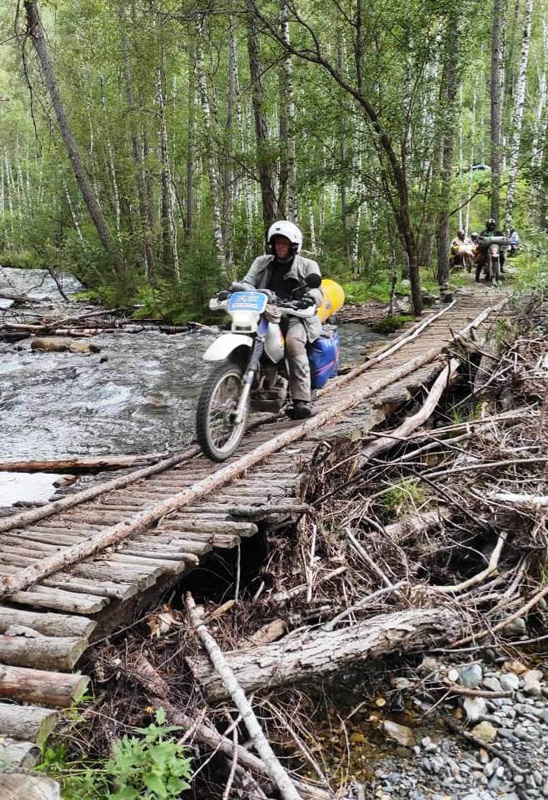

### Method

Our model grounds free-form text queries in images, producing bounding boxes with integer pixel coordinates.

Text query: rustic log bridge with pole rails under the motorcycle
[0,291,505,769]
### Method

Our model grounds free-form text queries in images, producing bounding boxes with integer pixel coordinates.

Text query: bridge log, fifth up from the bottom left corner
[0,628,88,672]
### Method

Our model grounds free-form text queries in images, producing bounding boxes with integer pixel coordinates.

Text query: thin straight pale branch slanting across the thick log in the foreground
[185,592,300,800]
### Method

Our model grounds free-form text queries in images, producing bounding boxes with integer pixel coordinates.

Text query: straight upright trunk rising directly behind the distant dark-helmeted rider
[491,0,506,221]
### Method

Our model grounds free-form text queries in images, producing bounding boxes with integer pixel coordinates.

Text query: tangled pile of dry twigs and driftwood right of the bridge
[56,297,548,798]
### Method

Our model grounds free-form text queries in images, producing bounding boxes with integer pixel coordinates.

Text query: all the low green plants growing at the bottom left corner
[36,708,190,800]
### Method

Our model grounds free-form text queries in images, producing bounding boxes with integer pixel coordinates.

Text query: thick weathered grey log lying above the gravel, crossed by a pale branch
[187,608,463,700]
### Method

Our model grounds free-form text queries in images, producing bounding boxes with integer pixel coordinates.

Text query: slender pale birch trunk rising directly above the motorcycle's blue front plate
[196,14,229,282]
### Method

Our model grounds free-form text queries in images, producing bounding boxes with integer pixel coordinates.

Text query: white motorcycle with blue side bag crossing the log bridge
[196,275,344,462]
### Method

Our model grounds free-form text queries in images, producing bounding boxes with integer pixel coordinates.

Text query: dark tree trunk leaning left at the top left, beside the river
[25,0,124,274]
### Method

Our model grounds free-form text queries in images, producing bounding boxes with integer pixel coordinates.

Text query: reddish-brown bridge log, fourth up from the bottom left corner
[0,664,89,708]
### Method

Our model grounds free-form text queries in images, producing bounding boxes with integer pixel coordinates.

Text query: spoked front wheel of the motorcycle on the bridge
[196,364,248,461]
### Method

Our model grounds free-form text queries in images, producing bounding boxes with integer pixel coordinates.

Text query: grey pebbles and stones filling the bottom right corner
[356,659,548,800]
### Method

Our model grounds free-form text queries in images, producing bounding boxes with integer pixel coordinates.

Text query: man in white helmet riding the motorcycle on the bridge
[239,220,323,419]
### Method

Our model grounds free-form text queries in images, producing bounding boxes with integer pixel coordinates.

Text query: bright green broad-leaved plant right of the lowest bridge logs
[105,708,190,800]
